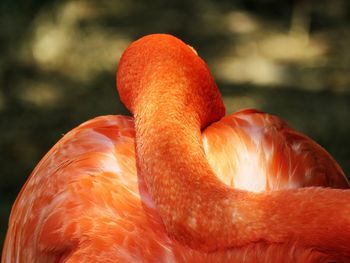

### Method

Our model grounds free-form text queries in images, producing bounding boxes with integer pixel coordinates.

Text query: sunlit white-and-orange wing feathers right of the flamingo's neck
[203,110,349,192]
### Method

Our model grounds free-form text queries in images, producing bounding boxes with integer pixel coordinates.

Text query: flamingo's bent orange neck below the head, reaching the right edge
[135,91,350,260]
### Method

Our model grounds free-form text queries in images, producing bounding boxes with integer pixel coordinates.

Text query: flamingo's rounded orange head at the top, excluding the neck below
[117,34,225,127]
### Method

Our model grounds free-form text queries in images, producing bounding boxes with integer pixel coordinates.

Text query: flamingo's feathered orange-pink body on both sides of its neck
[3,111,347,262]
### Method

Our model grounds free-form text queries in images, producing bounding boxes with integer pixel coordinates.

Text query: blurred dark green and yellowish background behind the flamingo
[0,0,350,251]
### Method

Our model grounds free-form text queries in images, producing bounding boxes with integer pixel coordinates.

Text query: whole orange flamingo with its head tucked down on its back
[2,34,350,263]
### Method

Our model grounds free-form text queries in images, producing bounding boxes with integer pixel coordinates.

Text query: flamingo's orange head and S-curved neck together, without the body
[117,35,350,257]
